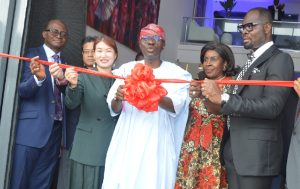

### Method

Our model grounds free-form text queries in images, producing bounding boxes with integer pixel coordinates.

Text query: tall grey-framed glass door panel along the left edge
[0,0,29,189]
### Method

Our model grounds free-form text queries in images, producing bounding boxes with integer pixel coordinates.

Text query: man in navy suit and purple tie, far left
[11,20,68,189]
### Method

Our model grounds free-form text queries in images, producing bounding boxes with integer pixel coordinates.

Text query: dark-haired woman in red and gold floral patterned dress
[175,42,237,189]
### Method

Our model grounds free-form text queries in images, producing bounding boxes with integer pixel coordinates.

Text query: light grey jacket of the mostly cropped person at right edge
[286,100,300,189]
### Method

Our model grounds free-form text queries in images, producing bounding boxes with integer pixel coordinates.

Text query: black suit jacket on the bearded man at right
[221,45,294,176]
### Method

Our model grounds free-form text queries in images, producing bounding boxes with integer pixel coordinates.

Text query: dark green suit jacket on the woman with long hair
[65,70,116,166]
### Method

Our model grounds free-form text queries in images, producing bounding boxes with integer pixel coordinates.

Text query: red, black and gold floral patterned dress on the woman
[175,78,231,189]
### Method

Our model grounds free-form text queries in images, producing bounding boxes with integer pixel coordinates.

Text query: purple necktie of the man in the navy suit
[52,54,62,121]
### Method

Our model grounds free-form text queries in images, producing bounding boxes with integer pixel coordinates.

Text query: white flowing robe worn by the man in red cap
[102,61,191,189]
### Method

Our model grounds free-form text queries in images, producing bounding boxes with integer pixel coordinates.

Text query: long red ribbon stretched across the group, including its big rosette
[0,53,294,112]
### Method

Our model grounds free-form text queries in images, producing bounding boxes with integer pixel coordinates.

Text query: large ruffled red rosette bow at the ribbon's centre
[123,63,167,112]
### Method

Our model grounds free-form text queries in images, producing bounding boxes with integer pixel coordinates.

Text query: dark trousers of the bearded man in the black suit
[223,138,274,189]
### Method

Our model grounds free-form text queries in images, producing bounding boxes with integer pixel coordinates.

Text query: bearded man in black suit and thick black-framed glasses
[201,8,294,189]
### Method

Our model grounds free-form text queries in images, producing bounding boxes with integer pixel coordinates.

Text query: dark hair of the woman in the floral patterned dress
[200,42,238,76]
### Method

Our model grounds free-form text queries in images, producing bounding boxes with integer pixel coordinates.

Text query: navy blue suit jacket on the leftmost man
[16,46,65,148]
